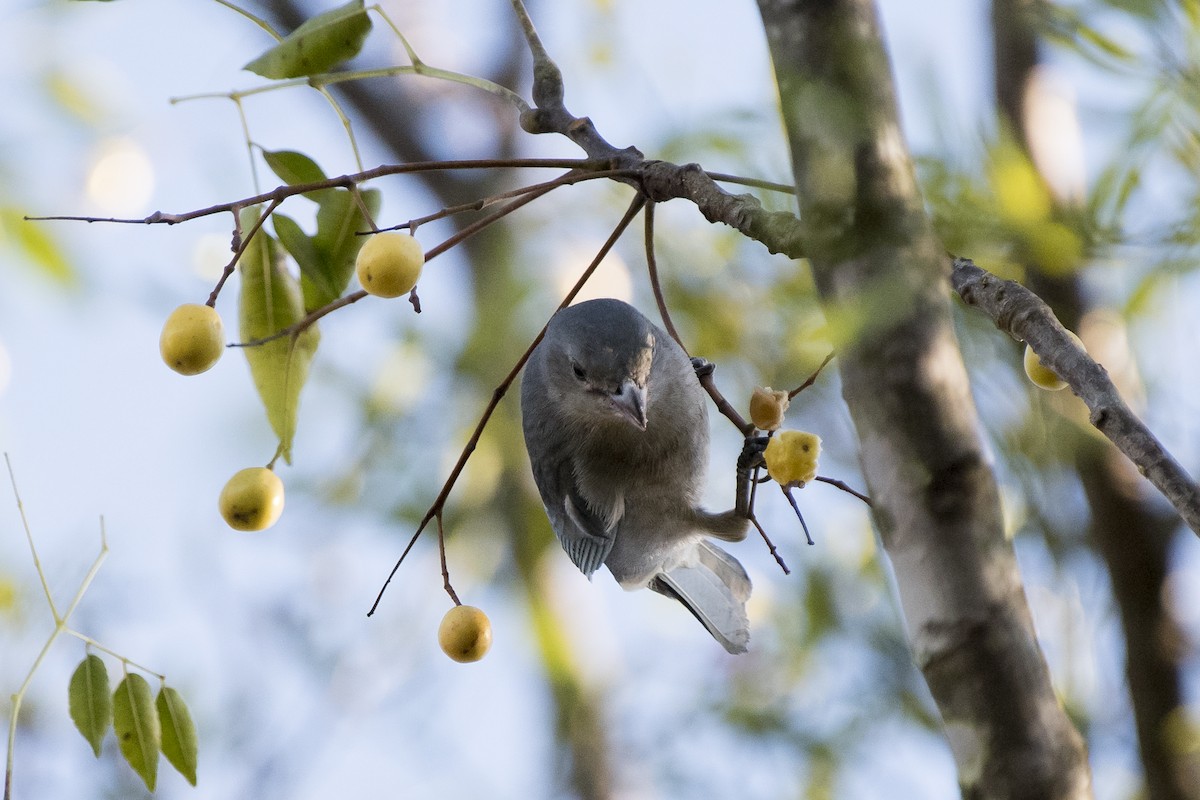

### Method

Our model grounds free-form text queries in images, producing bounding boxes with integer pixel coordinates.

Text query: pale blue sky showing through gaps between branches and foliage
[0,0,1200,800]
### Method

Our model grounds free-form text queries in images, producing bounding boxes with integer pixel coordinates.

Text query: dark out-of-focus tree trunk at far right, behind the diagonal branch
[991,0,1200,800]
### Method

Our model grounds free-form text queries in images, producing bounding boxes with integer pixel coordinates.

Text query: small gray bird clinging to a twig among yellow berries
[521,299,750,652]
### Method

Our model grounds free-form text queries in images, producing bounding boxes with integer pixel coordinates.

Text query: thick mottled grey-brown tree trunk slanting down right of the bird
[758,0,1091,799]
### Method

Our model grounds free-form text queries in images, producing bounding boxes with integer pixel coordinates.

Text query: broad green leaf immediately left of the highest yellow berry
[305,190,380,308]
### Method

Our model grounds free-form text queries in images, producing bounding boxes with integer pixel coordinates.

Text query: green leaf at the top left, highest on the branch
[242,0,371,78]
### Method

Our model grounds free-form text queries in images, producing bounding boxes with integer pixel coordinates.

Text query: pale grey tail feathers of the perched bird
[649,539,750,652]
